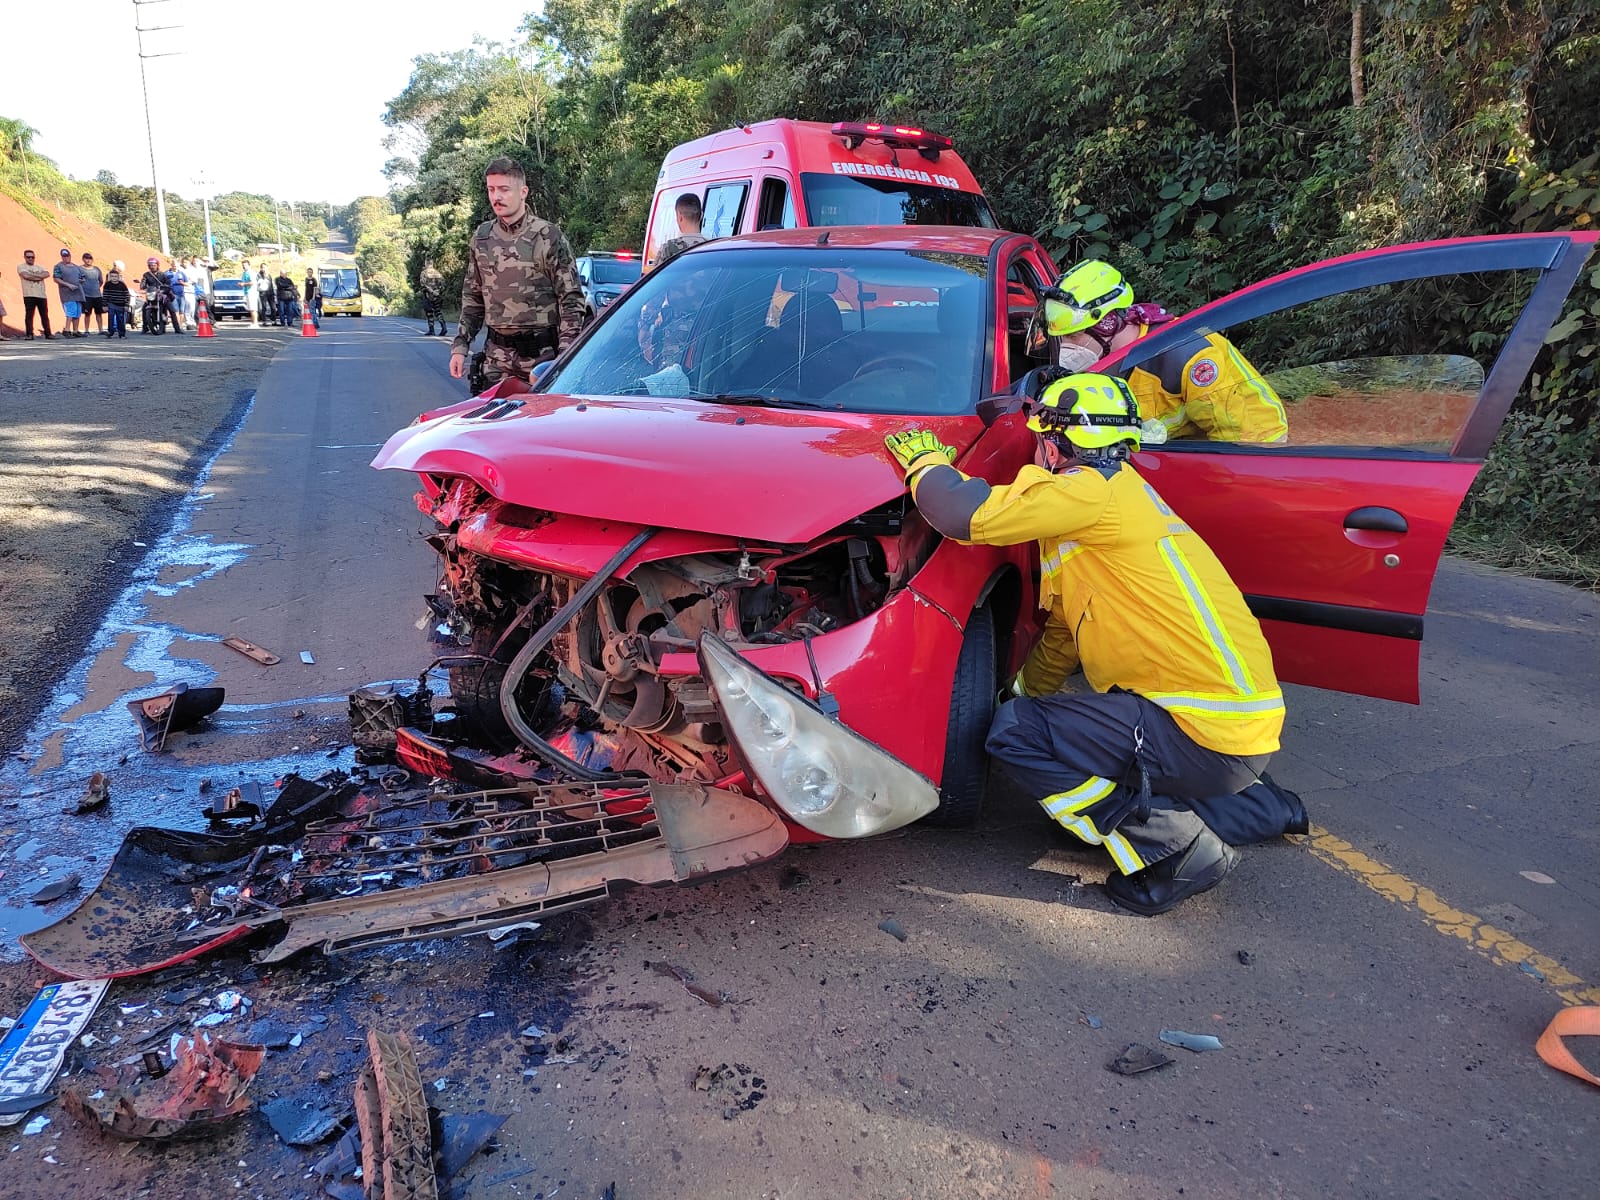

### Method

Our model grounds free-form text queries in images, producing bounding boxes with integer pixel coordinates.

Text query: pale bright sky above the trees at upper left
[0,0,541,205]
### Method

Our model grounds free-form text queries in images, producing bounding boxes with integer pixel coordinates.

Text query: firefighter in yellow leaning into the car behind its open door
[1038,259,1290,443]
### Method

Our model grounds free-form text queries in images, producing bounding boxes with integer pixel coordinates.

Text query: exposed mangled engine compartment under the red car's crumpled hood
[429,480,939,782]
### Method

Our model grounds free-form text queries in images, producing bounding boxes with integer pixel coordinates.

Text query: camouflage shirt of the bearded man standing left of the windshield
[450,210,584,354]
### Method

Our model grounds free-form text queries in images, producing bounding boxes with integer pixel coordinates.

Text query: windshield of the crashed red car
[553,246,989,413]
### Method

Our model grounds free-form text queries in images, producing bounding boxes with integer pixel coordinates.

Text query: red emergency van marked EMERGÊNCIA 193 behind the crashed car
[645,117,997,269]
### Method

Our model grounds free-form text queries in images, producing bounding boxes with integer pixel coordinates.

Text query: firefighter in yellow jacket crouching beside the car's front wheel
[886,374,1307,915]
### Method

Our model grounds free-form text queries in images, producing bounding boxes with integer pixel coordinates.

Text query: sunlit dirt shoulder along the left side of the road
[0,334,285,752]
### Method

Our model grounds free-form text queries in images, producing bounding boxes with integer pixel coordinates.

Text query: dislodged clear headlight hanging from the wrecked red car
[699,634,939,837]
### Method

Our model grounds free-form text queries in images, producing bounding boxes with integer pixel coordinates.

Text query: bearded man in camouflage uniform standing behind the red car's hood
[450,158,584,384]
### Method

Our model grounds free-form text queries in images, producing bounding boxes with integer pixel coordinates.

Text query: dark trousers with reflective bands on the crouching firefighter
[989,691,1298,875]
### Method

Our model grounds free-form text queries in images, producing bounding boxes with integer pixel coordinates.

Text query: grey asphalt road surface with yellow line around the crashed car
[0,318,1600,1200]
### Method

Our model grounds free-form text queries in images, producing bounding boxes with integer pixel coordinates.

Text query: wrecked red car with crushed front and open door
[373,227,1597,853]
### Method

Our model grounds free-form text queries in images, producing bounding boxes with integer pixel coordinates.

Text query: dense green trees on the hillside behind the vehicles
[371,0,1600,581]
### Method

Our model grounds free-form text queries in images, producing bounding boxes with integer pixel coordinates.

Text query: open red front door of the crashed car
[1091,232,1600,704]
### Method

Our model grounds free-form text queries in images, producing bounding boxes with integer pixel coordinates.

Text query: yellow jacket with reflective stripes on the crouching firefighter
[912,464,1283,755]
